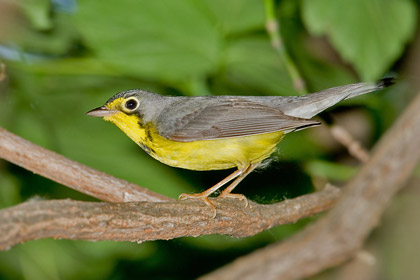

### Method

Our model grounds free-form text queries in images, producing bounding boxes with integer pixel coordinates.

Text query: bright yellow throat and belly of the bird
[106,114,284,170]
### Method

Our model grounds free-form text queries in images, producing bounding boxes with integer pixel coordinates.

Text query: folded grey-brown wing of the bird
[160,98,319,142]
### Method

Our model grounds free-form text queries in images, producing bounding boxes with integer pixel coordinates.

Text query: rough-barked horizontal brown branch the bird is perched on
[0,187,340,250]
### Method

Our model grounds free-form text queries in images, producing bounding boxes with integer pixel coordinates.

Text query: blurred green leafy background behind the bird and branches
[0,0,417,279]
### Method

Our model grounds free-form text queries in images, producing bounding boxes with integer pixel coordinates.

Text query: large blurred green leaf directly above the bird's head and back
[76,0,221,82]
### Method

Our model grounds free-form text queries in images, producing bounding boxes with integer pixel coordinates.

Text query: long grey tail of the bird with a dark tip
[273,78,395,119]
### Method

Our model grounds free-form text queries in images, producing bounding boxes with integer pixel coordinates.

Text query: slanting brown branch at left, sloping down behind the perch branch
[0,128,173,202]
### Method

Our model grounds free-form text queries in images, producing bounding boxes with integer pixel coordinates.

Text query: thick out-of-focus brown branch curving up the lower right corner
[203,91,420,280]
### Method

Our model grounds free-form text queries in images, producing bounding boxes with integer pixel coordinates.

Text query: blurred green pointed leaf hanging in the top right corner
[302,0,417,80]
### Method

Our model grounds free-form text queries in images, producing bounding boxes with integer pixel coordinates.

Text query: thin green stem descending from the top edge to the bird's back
[264,0,308,94]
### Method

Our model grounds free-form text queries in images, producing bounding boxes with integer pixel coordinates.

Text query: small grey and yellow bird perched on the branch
[87,78,395,210]
